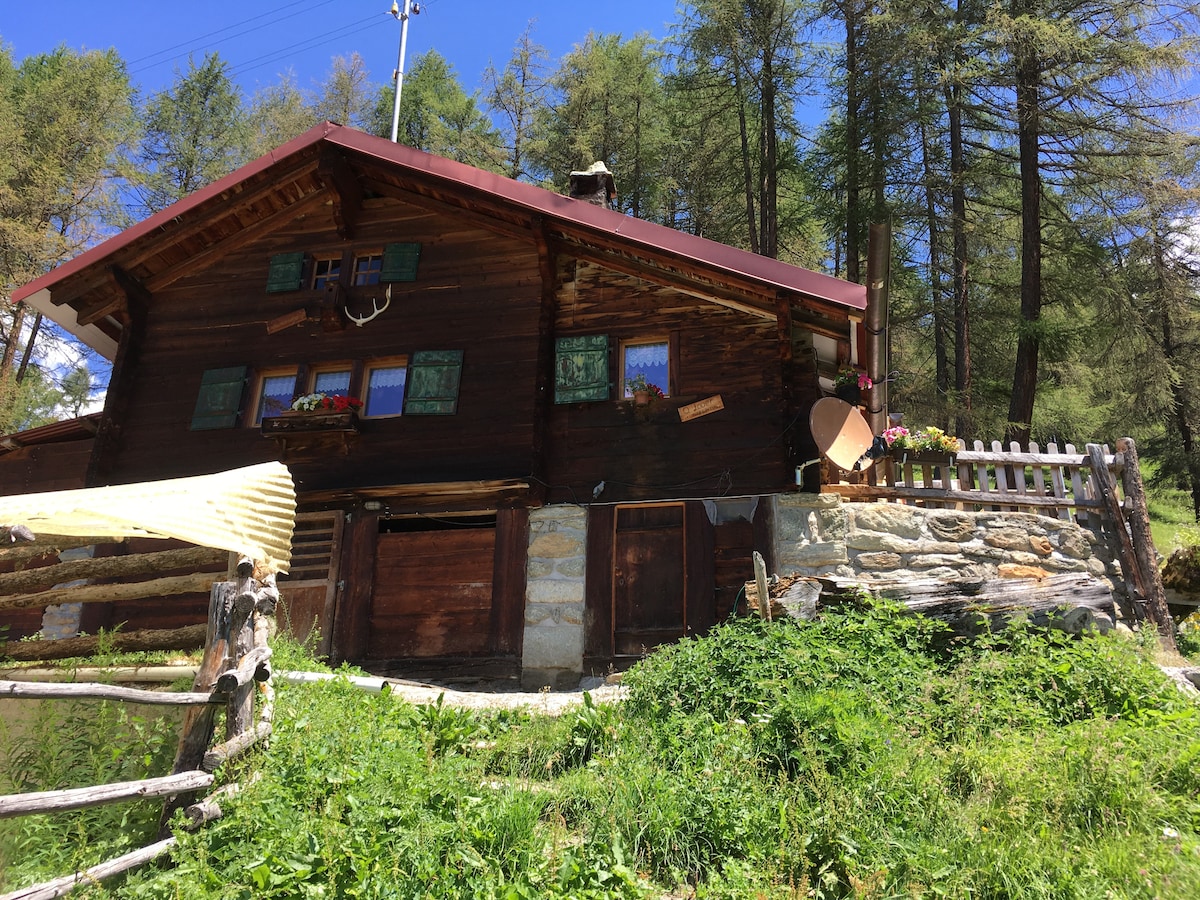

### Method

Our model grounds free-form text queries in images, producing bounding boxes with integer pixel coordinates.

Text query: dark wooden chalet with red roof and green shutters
[0,122,866,684]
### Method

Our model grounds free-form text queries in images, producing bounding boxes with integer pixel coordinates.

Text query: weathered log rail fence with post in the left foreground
[0,561,278,900]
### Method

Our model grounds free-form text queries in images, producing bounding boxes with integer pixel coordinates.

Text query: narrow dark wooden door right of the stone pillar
[612,503,689,656]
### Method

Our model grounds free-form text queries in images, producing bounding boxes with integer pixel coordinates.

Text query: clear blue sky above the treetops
[0,0,677,95]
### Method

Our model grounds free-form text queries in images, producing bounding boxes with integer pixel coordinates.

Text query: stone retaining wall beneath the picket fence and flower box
[770,493,1124,593]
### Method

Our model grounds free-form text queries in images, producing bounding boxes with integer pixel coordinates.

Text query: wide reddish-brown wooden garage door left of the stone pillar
[367,527,496,660]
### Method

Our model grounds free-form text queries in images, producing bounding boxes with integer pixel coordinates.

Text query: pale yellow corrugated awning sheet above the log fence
[0,462,296,572]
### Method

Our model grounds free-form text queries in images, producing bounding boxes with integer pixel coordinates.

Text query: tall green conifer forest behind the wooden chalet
[7,0,1200,521]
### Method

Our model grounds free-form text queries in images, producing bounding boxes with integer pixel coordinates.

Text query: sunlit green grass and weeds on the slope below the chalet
[0,605,1200,900]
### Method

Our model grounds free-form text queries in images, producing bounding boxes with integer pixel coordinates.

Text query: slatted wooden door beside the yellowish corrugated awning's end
[278,510,344,656]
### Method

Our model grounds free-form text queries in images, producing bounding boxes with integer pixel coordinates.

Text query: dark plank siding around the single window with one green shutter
[546,260,801,503]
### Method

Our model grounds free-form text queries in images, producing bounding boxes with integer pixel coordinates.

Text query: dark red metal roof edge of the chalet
[12,122,866,310]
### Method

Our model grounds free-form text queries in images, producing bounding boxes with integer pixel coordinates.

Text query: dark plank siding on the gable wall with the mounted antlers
[94,194,540,493]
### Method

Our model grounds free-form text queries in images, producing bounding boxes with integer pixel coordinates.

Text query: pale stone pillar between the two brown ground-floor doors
[521,506,588,690]
